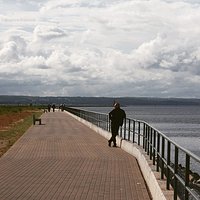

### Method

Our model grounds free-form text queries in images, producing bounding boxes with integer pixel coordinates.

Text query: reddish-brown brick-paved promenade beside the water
[0,112,150,200]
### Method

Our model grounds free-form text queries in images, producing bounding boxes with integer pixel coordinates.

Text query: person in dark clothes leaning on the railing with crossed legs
[108,103,126,147]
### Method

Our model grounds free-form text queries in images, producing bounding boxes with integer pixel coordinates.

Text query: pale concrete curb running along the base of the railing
[65,111,173,200]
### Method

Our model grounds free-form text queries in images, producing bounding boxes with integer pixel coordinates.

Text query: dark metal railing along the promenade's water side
[66,108,200,200]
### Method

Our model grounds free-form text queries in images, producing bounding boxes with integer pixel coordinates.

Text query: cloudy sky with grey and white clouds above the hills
[0,0,200,98]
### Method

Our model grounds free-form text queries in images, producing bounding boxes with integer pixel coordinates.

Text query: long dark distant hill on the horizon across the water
[0,95,200,107]
